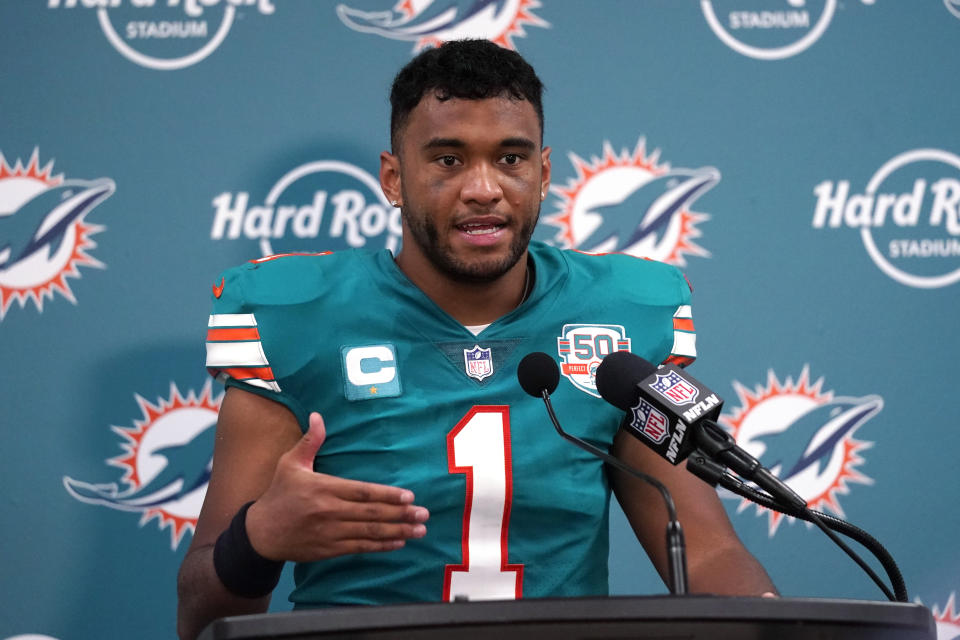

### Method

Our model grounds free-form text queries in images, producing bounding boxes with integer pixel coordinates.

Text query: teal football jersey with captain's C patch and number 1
[207,243,695,606]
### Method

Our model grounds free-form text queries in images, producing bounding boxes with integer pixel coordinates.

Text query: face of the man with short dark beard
[380,94,550,282]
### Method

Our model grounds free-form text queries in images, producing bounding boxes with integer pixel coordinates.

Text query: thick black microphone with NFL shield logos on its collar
[597,351,807,509]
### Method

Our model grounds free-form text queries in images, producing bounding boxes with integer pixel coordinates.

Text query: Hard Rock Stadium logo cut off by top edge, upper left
[47,0,276,71]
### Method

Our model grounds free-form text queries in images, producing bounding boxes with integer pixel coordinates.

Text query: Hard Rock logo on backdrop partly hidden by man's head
[210,160,402,256]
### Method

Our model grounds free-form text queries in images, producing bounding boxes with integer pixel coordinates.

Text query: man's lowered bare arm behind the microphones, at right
[610,431,776,596]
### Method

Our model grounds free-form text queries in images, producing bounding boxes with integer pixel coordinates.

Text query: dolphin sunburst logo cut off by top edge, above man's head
[337,0,550,52]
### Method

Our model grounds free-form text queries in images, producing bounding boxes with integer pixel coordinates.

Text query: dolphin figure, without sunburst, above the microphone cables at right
[757,395,883,480]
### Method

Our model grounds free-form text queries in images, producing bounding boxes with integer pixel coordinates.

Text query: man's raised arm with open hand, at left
[177,388,428,639]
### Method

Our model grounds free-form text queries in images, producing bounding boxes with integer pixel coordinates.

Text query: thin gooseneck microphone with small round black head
[517,351,687,595]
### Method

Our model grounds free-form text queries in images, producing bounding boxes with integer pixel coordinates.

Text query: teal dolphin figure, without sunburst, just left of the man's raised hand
[63,420,216,511]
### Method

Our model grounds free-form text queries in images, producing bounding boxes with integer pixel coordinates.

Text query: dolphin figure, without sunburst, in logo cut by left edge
[0,178,116,270]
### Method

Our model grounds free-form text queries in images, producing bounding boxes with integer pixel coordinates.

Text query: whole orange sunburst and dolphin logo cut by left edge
[0,149,116,320]
